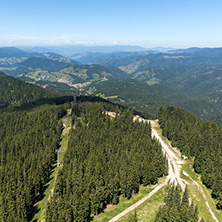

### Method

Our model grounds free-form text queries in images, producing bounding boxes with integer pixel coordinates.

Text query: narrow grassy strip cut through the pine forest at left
[33,116,71,222]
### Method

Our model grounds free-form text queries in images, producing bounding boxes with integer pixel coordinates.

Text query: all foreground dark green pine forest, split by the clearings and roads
[0,68,222,222]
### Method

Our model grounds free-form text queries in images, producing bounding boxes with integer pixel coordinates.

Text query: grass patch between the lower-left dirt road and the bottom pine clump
[119,186,166,222]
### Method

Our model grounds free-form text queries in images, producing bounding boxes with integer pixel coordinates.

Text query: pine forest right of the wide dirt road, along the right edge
[158,107,222,209]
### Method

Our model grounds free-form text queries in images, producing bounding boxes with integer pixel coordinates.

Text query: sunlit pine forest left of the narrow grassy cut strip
[0,105,65,222]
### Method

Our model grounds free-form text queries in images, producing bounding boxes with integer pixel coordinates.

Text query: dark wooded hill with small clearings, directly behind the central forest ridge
[86,79,186,118]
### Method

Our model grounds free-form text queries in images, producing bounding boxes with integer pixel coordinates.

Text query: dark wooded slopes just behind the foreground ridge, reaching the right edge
[85,79,222,124]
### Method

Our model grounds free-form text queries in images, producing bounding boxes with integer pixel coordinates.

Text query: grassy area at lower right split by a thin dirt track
[181,160,222,222]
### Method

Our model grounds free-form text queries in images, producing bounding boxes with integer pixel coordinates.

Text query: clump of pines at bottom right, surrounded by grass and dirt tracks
[155,183,201,222]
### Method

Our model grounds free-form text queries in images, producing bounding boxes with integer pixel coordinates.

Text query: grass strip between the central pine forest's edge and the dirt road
[93,177,165,222]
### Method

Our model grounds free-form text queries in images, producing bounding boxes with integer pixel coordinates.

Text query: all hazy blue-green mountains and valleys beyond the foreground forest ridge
[0,46,222,122]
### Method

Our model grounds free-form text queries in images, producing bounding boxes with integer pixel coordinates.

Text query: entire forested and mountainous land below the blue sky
[0,48,222,222]
